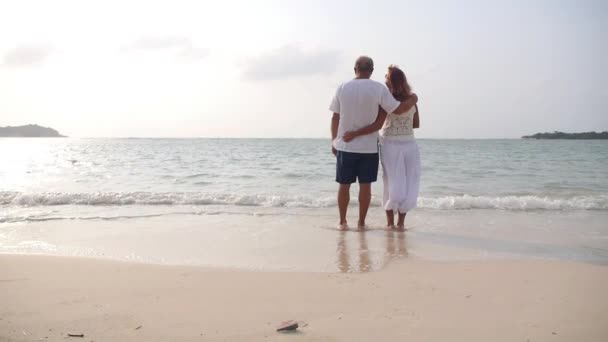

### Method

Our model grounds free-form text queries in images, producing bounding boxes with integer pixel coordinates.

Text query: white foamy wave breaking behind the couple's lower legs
[0,191,608,210]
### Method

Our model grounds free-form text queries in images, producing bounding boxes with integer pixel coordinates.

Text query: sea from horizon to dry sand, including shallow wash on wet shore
[0,138,608,271]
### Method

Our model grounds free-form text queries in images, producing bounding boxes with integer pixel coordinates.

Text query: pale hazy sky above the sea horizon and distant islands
[0,0,608,138]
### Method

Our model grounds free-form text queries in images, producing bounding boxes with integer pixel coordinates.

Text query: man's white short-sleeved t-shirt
[329,79,400,153]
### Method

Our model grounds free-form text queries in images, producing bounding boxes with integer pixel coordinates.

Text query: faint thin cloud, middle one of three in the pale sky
[120,36,209,60]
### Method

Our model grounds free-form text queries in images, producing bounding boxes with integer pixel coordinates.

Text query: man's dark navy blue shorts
[336,151,379,184]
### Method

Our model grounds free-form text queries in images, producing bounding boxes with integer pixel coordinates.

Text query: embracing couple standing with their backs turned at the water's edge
[329,56,420,230]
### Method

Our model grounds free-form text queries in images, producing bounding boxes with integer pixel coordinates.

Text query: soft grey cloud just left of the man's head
[244,46,341,81]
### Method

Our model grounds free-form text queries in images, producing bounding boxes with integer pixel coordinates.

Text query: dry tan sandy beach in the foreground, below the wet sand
[0,255,608,341]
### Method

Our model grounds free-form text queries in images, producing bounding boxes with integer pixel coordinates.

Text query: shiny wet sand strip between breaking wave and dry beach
[0,208,608,272]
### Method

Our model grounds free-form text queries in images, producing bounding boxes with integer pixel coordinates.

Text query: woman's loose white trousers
[380,140,420,214]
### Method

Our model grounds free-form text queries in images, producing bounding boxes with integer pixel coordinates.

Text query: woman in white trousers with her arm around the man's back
[344,65,420,231]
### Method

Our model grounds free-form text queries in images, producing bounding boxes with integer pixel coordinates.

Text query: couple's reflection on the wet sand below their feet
[336,231,407,272]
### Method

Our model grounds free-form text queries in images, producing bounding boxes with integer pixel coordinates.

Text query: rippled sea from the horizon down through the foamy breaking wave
[0,139,608,214]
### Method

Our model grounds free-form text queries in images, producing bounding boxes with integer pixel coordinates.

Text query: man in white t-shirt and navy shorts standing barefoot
[329,56,418,230]
